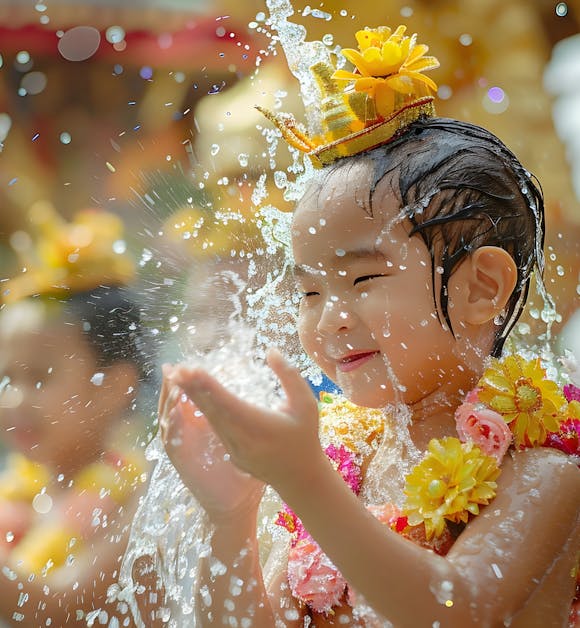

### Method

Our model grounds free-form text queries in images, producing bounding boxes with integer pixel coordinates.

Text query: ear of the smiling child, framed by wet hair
[449,246,518,325]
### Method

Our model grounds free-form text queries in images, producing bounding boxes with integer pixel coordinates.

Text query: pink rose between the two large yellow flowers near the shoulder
[455,401,512,463]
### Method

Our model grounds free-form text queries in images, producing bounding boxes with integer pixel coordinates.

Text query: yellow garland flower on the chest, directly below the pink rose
[403,437,500,540]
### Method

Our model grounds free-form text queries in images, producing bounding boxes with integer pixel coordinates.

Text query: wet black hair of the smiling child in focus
[327,118,545,357]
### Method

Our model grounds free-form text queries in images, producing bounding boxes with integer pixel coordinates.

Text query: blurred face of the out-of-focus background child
[0,312,108,465]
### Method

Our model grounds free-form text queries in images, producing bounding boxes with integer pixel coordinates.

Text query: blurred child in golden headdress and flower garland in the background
[0,208,147,626]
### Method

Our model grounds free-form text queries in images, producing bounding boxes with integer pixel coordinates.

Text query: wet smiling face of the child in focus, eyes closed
[293,163,474,407]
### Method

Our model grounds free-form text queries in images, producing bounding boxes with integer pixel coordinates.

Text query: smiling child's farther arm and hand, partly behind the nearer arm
[156,367,302,628]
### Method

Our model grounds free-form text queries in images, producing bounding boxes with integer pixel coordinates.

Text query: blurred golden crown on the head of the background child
[1,202,135,303]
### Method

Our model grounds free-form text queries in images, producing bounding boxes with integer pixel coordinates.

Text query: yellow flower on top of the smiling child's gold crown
[332,26,439,118]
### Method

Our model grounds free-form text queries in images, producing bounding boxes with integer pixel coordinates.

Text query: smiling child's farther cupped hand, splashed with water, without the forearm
[159,366,264,523]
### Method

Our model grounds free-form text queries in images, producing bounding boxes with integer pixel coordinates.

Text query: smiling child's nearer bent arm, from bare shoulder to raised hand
[175,355,580,626]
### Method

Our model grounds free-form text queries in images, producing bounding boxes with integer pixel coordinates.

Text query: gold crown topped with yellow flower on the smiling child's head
[258,26,439,168]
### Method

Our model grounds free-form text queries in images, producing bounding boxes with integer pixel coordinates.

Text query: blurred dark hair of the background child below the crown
[60,285,153,381]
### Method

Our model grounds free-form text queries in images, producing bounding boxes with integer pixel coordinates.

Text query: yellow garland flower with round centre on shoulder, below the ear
[477,355,566,447]
